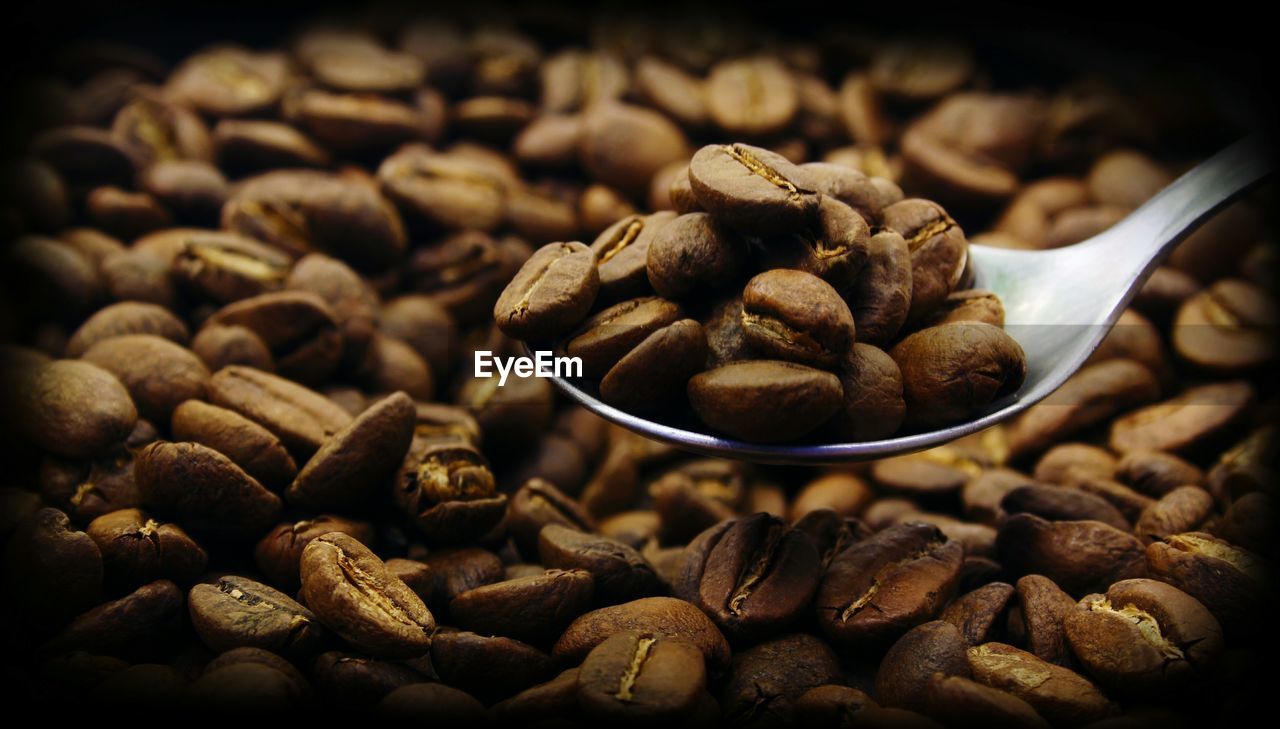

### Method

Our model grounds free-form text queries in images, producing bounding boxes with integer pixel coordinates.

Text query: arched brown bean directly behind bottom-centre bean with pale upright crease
[552,597,730,675]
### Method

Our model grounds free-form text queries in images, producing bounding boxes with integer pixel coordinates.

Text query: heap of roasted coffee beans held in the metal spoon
[493,138,1027,443]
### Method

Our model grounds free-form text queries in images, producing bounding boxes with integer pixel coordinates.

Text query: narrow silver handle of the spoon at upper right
[1082,134,1275,263]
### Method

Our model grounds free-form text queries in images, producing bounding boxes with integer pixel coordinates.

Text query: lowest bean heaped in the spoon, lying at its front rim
[689,359,844,443]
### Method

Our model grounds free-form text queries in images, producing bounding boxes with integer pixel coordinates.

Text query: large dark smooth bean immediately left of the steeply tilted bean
[134,441,280,538]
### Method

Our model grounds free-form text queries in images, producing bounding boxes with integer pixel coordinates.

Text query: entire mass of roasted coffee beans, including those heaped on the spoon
[0,4,1277,728]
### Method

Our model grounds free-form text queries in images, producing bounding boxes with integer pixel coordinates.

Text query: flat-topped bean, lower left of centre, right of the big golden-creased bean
[449,569,594,646]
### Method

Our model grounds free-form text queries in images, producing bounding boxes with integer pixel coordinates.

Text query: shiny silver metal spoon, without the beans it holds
[537,136,1274,464]
